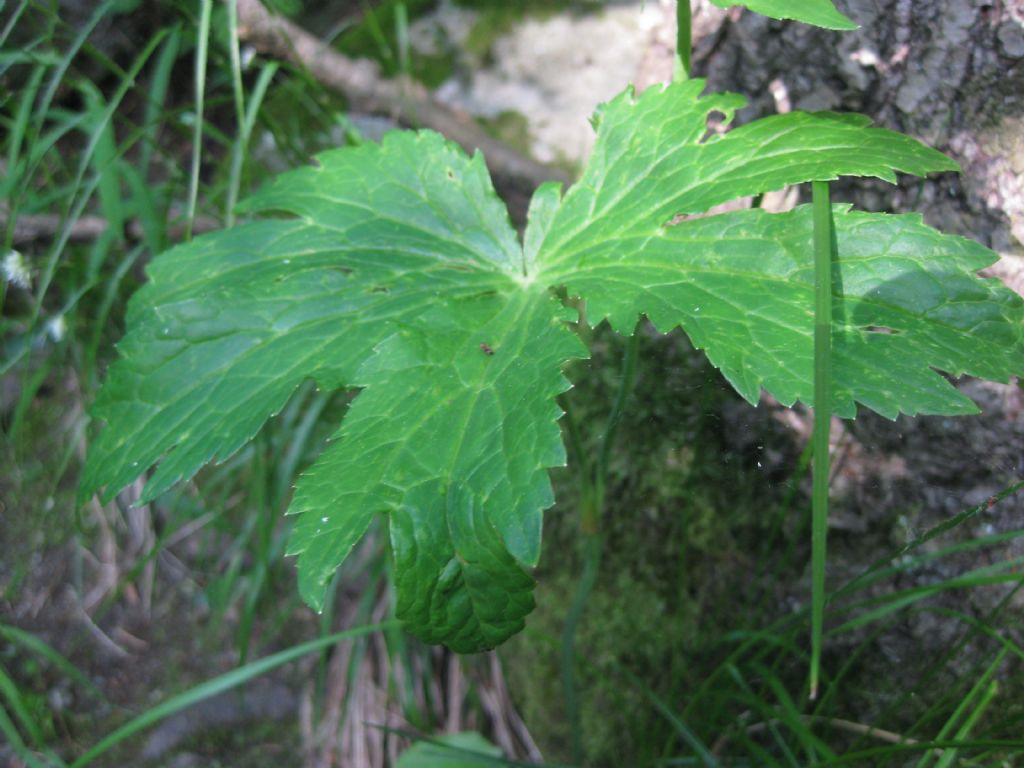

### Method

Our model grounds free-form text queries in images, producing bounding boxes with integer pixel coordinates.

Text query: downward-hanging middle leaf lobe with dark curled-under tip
[291,287,586,650]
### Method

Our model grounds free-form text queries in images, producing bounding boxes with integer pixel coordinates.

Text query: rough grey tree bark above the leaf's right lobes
[696,0,1024,282]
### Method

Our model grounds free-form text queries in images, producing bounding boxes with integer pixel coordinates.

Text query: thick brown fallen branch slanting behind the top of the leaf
[238,0,570,219]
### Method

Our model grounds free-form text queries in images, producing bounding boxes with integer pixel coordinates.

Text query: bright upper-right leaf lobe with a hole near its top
[527,80,957,264]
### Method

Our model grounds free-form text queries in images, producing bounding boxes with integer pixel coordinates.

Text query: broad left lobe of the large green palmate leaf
[83,134,521,500]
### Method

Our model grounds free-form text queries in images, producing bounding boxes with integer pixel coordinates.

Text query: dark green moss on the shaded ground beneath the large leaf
[504,330,799,766]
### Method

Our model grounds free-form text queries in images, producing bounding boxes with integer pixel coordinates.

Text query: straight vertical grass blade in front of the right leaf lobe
[810,181,835,700]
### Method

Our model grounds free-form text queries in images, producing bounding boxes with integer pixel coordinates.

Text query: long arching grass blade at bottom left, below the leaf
[71,621,398,768]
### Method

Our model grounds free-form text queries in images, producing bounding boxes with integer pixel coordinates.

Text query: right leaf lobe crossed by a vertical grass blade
[544,207,1024,418]
